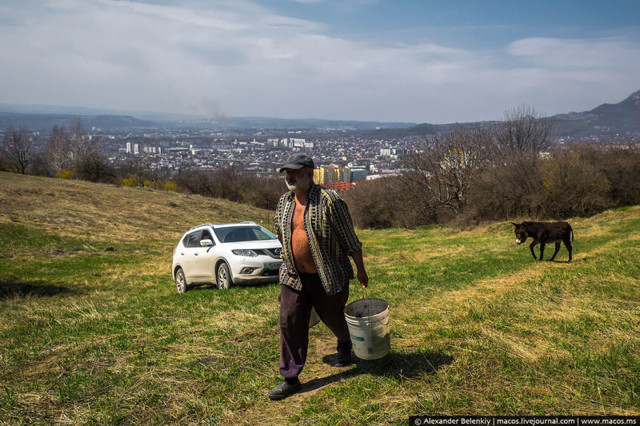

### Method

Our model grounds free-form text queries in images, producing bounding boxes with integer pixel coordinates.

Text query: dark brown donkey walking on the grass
[511,222,573,262]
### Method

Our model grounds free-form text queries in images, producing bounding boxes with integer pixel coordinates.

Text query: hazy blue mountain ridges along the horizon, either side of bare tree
[0,91,640,140]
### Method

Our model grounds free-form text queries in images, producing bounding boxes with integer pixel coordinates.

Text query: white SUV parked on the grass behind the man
[172,222,282,293]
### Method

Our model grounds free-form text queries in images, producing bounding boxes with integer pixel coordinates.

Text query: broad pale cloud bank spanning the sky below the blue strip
[0,0,640,123]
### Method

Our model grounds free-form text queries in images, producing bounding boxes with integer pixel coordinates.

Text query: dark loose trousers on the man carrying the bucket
[278,274,350,379]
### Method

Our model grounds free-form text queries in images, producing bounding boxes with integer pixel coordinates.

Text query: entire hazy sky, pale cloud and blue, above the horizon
[0,0,640,123]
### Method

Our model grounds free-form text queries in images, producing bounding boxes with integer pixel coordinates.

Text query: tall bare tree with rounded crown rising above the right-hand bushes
[496,106,551,153]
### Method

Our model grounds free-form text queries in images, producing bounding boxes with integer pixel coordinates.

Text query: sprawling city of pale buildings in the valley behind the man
[27,122,425,185]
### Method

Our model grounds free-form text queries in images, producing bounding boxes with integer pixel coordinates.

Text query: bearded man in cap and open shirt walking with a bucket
[269,153,369,400]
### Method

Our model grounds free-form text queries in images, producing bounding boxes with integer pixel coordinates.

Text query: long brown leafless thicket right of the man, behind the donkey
[364,140,640,228]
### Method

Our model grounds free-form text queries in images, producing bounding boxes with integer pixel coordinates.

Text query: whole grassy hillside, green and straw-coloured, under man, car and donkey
[0,173,640,425]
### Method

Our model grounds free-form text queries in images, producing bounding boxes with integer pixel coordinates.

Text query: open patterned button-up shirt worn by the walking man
[275,184,362,295]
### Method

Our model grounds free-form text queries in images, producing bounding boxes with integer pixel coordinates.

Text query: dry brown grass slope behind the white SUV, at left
[0,172,273,243]
